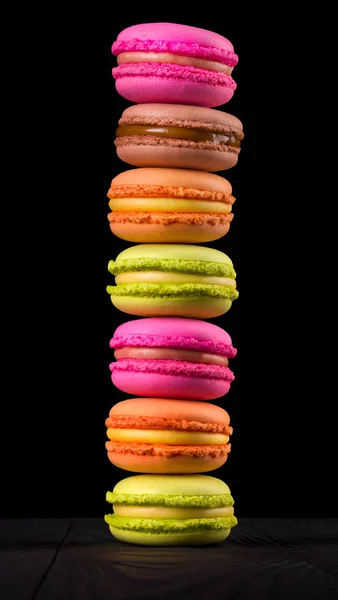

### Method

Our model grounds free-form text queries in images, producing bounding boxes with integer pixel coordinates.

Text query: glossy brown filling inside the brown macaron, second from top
[116,125,241,148]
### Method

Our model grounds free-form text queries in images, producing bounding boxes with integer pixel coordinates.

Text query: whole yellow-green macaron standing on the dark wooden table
[104,475,237,546]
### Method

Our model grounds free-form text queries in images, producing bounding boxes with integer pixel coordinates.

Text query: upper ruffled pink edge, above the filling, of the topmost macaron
[112,39,238,67]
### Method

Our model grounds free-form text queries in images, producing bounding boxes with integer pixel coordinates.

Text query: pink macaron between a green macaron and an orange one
[110,317,237,400]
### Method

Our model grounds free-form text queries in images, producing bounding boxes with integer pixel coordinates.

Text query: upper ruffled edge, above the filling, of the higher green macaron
[108,257,236,279]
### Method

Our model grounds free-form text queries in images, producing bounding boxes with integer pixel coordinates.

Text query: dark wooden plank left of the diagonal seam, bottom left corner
[0,519,70,600]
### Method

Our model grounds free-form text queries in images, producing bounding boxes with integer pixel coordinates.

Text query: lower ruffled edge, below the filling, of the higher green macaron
[107,283,238,300]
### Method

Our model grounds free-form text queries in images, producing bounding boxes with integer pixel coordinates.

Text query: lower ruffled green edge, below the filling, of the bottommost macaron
[104,515,237,533]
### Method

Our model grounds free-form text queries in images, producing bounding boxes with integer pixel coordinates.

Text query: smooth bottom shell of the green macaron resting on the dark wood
[109,525,231,546]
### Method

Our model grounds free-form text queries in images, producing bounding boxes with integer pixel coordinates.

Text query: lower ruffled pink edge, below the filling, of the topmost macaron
[112,63,237,90]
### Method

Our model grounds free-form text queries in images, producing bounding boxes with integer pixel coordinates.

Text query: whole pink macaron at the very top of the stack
[112,23,238,107]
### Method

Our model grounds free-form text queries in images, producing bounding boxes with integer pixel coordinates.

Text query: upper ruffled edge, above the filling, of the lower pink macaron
[109,334,237,358]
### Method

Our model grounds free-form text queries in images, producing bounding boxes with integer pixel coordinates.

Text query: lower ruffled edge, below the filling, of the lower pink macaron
[109,358,235,382]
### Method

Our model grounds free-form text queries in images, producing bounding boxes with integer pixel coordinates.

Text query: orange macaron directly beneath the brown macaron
[107,168,235,244]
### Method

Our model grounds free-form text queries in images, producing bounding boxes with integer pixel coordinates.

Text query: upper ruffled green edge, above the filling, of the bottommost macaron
[106,492,234,508]
